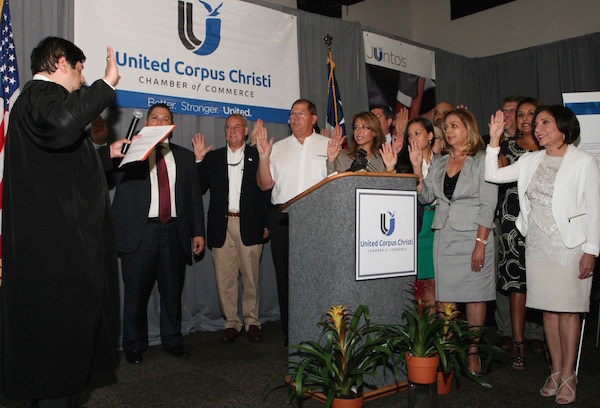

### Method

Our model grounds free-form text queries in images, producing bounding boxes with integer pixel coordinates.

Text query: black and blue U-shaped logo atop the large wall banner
[177,0,223,55]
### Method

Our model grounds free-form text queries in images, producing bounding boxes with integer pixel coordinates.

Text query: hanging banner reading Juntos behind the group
[363,31,435,118]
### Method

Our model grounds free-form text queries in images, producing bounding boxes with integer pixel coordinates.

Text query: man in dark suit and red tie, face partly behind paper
[113,103,204,364]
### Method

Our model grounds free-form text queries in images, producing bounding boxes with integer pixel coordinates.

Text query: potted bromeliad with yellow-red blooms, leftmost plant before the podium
[288,305,393,408]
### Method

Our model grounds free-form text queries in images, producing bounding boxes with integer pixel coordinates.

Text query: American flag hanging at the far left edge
[0,0,19,285]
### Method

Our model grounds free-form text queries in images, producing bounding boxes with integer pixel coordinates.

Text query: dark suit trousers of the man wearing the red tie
[120,220,186,353]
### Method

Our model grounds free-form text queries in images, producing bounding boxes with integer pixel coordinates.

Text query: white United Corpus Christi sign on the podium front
[356,189,417,280]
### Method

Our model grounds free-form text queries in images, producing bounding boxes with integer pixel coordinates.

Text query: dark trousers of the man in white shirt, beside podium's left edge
[270,205,290,338]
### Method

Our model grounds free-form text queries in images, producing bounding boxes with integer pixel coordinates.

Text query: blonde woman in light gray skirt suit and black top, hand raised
[410,109,498,373]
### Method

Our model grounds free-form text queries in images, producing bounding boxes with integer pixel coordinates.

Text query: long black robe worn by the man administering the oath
[0,80,119,398]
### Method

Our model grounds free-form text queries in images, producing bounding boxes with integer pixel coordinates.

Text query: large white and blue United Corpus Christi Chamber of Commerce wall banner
[75,0,300,123]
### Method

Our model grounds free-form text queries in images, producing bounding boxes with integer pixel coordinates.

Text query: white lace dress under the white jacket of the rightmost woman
[525,155,592,313]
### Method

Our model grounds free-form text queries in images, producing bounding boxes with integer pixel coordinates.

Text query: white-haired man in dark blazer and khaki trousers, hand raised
[194,114,270,343]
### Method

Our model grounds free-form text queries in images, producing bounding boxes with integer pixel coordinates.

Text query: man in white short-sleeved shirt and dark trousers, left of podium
[252,99,329,345]
